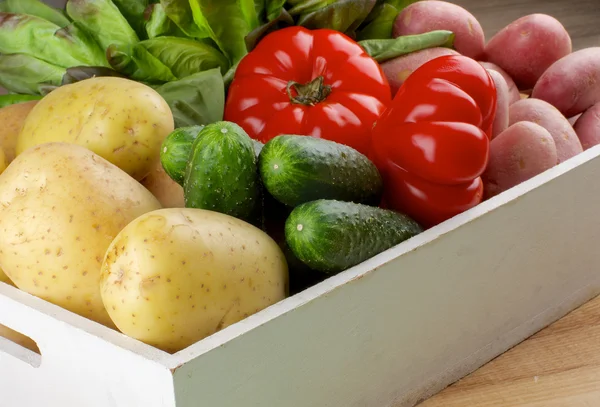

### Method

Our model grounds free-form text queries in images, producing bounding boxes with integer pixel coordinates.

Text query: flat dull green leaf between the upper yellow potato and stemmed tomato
[155,69,225,128]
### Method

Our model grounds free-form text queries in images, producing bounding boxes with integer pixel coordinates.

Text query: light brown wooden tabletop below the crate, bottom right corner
[419,297,600,407]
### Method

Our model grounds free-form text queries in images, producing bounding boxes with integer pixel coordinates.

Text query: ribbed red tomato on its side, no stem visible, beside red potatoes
[370,55,496,227]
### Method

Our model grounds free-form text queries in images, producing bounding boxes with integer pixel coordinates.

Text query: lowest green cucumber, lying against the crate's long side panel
[285,199,423,274]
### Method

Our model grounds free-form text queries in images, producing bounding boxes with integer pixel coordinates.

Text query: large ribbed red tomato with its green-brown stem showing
[225,26,392,154]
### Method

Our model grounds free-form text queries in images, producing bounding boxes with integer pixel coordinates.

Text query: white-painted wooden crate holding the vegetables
[0,146,600,407]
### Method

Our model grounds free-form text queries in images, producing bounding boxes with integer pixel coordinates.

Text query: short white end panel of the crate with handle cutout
[0,283,175,407]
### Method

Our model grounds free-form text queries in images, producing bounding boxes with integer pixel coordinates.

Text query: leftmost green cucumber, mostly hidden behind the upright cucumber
[160,126,204,186]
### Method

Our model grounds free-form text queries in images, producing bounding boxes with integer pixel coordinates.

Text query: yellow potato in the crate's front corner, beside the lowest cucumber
[100,208,288,352]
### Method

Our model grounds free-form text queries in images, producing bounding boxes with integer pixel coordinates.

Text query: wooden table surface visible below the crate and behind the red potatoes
[419,0,600,407]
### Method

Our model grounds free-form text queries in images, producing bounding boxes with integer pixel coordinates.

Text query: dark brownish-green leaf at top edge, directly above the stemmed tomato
[290,0,376,37]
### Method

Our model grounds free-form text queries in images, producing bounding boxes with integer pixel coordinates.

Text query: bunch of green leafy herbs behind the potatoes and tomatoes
[0,0,452,127]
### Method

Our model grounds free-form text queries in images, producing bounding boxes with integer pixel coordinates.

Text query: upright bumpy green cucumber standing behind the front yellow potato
[183,121,260,223]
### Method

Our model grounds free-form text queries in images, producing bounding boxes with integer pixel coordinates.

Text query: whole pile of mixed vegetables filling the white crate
[0,0,600,352]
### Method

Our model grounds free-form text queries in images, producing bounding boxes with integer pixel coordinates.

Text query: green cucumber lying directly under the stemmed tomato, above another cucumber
[258,135,383,207]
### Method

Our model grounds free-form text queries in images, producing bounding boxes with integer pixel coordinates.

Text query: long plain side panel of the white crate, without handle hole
[175,149,600,407]
